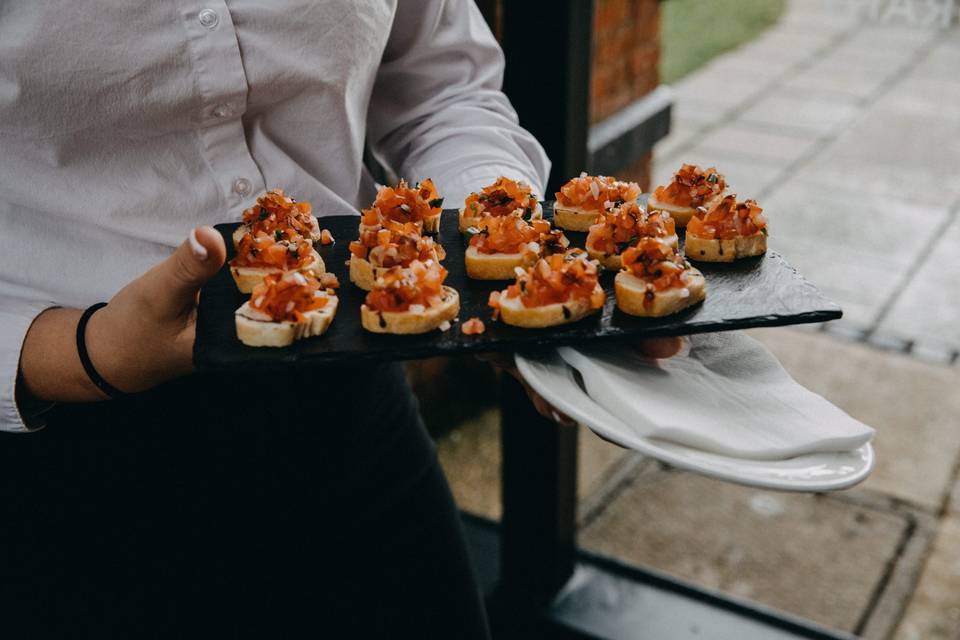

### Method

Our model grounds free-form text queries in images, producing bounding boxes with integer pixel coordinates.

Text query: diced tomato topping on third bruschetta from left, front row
[498,249,605,309]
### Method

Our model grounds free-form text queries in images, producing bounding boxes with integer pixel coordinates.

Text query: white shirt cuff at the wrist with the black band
[0,297,56,432]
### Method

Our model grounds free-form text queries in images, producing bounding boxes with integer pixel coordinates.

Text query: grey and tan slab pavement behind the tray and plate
[440,0,960,640]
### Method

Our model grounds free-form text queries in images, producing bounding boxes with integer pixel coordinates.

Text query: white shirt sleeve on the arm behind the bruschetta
[367,0,550,206]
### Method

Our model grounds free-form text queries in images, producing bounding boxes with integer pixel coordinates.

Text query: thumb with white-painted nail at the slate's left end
[155,227,227,312]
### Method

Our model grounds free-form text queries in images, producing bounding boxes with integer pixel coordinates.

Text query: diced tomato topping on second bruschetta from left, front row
[366,260,447,311]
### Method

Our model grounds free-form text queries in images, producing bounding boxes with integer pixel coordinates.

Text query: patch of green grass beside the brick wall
[660,0,786,84]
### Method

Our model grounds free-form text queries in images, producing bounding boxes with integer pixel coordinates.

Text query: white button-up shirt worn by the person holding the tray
[0,0,549,431]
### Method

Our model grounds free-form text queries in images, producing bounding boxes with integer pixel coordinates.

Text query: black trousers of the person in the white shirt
[0,365,488,638]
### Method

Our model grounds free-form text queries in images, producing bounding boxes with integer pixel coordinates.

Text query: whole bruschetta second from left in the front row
[360,260,460,334]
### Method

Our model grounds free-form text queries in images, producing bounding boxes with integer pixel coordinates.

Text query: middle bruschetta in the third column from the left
[464,214,570,280]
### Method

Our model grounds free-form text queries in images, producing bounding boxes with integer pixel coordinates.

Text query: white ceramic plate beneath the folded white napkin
[516,351,874,492]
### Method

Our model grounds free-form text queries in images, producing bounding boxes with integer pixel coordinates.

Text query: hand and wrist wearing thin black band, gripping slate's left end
[20,227,226,401]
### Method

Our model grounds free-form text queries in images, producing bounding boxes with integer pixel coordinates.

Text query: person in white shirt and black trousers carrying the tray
[0,0,669,638]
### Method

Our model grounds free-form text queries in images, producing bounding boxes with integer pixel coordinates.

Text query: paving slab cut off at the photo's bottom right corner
[894,514,960,640]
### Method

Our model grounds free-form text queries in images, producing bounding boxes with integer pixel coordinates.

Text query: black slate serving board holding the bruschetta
[193,203,842,371]
